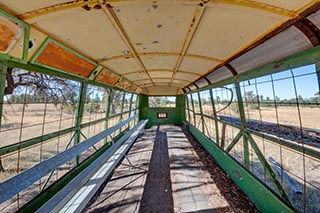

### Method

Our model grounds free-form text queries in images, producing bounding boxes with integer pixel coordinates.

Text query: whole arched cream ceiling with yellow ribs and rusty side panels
[0,0,320,95]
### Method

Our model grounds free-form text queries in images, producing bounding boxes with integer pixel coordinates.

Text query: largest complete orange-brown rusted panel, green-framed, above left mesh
[36,42,96,77]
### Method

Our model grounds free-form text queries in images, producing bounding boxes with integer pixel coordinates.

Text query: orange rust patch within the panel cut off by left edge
[0,17,19,52]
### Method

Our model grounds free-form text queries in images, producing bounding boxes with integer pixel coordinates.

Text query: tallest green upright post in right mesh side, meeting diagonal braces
[234,82,250,170]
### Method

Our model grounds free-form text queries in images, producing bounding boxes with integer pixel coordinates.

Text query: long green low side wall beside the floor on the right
[189,125,294,212]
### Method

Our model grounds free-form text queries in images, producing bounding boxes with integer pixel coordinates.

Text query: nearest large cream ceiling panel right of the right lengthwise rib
[188,4,287,59]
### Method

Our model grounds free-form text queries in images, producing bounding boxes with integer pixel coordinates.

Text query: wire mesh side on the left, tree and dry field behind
[0,68,138,212]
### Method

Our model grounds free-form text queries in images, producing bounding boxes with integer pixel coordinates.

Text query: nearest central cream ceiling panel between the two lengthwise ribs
[113,3,196,53]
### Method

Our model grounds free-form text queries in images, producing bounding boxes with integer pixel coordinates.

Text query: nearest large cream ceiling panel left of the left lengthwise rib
[27,7,128,60]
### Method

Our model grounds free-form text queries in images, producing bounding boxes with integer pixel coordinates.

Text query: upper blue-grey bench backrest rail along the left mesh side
[0,115,137,203]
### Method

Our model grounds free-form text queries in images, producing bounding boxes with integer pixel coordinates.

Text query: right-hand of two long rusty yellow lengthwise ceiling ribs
[170,3,206,83]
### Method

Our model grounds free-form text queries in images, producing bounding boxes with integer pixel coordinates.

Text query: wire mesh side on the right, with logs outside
[186,65,320,212]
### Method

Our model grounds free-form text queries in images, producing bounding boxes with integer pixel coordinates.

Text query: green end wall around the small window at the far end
[139,95,185,128]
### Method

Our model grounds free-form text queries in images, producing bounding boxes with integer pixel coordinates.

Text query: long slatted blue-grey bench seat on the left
[36,120,148,213]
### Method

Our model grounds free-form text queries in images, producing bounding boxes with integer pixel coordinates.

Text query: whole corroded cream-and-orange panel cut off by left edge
[0,15,24,54]
